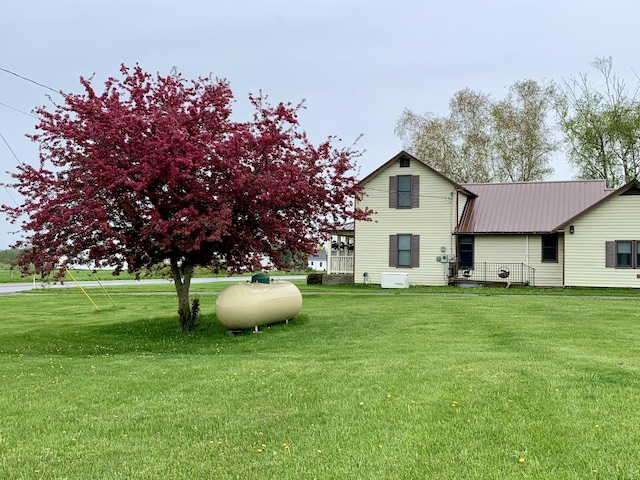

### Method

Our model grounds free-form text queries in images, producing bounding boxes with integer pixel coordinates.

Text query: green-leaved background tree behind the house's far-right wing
[556,57,640,187]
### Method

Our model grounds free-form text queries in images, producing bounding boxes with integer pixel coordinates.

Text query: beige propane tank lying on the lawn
[216,281,302,330]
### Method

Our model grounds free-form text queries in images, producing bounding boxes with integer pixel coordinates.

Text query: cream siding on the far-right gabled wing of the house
[564,195,640,288]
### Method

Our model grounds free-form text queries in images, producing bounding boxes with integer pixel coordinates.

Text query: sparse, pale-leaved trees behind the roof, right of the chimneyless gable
[396,80,557,183]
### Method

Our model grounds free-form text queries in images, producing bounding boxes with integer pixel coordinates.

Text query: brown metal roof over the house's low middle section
[456,180,611,233]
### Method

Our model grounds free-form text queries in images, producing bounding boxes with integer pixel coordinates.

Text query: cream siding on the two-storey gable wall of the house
[355,161,457,285]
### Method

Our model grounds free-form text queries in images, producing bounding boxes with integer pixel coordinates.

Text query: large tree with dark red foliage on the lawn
[1,65,369,331]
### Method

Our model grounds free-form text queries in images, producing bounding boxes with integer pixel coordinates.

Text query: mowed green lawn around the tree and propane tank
[0,287,640,480]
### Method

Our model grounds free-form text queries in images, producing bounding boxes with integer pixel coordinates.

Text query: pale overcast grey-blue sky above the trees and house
[0,0,640,249]
